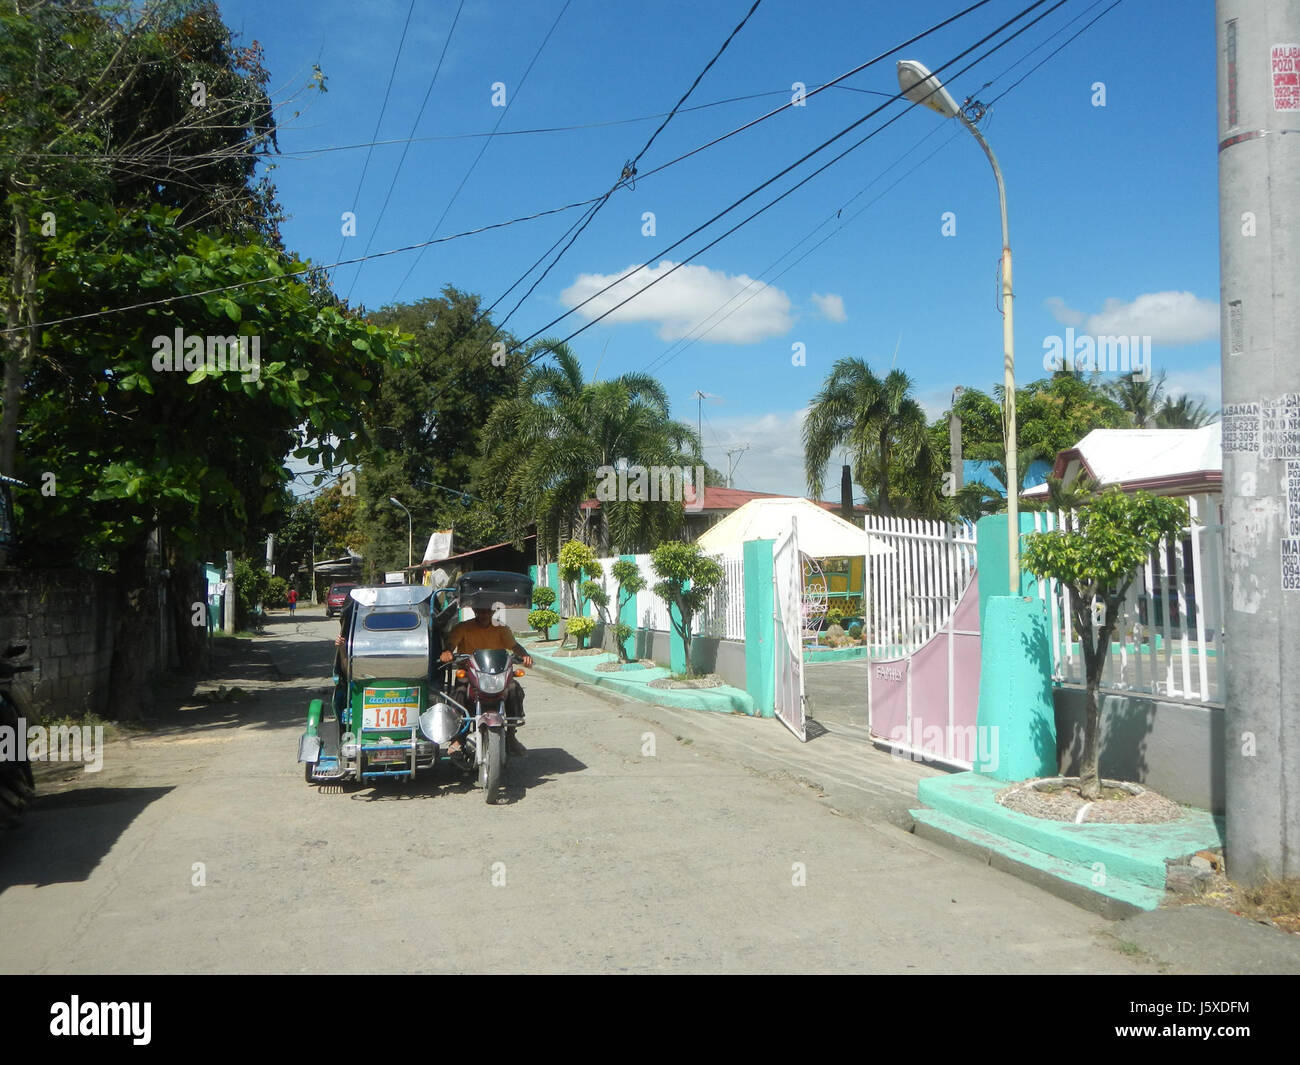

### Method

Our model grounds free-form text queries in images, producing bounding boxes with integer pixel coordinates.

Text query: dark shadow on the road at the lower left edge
[0,787,172,893]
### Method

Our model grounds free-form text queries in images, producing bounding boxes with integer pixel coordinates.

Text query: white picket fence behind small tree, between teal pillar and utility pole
[1035,495,1226,706]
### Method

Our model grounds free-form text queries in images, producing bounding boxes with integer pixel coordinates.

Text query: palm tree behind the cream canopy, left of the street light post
[803,358,939,514]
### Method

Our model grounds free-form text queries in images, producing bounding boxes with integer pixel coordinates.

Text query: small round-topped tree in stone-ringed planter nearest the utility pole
[1021,489,1188,800]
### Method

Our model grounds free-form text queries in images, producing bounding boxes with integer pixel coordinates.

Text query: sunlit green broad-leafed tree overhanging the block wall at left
[7,203,400,713]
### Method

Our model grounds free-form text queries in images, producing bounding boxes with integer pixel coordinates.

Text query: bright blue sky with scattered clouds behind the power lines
[221,0,1219,494]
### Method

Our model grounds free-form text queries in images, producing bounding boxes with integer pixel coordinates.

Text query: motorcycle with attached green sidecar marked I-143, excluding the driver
[298,571,533,802]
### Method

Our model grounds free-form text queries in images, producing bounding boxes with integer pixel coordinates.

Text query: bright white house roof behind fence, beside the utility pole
[1021,421,1223,498]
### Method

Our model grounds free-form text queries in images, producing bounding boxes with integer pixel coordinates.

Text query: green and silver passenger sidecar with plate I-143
[298,585,454,784]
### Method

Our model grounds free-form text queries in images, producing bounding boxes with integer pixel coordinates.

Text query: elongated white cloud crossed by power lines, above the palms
[560,259,793,343]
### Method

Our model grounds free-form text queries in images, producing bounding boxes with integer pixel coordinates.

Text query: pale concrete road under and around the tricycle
[0,609,1173,973]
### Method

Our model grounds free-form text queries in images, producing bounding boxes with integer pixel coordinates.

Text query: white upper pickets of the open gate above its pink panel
[863,514,975,658]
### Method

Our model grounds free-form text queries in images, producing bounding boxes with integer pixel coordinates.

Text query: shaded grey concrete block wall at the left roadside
[0,568,114,718]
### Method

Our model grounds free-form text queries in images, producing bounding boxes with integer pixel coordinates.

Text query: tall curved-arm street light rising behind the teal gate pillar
[898,60,1021,596]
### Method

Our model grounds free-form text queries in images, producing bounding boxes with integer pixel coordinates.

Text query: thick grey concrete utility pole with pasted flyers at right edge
[1210,0,1300,883]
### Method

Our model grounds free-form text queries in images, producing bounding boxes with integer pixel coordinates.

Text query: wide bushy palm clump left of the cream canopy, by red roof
[478,341,699,559]
